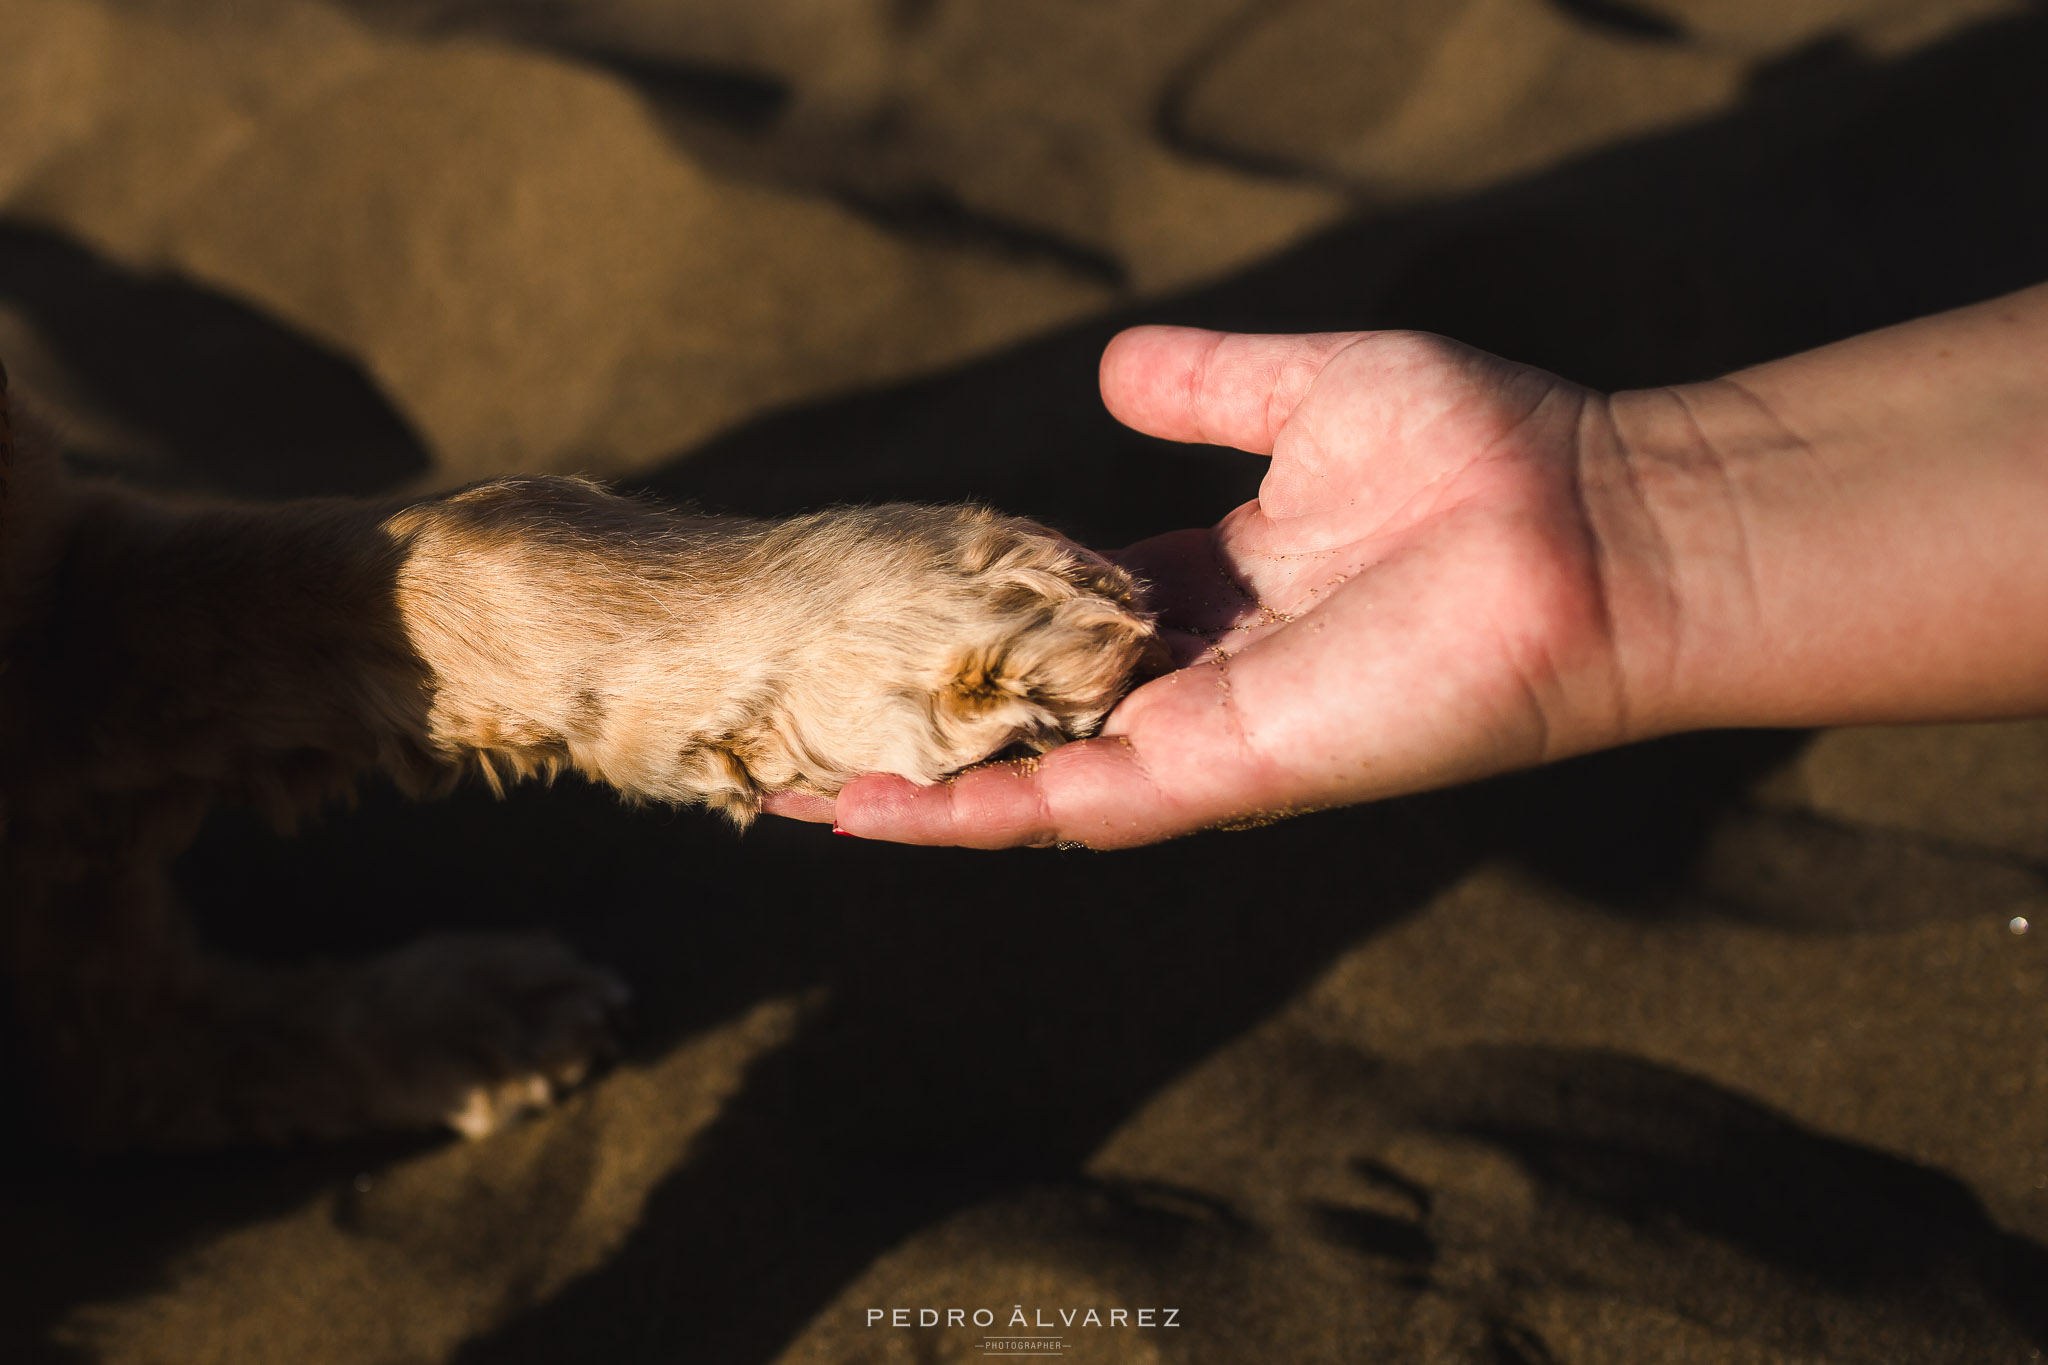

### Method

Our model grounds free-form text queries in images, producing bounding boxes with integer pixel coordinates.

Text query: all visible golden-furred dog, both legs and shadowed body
[0,368,1163,1144]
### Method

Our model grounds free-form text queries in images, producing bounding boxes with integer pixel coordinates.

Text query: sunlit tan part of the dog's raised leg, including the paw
[393,497,1165,825]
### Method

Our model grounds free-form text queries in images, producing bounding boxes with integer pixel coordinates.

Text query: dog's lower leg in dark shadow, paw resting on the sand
[16,876,627,1146]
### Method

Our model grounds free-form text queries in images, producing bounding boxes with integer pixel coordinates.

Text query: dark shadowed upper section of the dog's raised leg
[0,487,448,804]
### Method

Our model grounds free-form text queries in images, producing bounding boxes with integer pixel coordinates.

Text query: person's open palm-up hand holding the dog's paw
[770,327,1626,847]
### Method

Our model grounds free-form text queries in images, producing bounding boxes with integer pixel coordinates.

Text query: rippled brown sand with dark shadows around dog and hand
[0,0,2048,1365]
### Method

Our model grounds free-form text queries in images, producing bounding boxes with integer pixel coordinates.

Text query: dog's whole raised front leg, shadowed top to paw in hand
[16,479,1163,823]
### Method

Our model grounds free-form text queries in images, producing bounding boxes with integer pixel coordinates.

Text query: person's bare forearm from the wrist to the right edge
[1595,287,2048,735]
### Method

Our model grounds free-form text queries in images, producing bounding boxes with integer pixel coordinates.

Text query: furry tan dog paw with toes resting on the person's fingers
[682,505,1165,825]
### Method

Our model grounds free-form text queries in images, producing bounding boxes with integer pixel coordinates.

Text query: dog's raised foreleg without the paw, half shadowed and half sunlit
[12,479,737,804]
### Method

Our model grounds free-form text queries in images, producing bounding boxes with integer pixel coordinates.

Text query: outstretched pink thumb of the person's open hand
[1102,327,1364,454]
